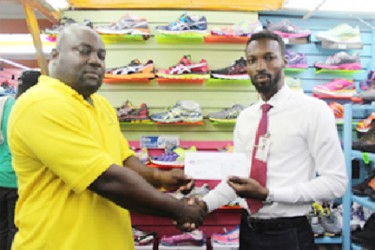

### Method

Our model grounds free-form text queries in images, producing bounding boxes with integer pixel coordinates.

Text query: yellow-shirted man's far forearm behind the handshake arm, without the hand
[123,156,162,188]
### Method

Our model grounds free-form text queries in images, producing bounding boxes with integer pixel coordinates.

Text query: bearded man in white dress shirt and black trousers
[201,31,347,250]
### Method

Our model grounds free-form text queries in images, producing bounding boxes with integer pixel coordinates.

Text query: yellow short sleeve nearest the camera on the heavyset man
[14,97,114,193]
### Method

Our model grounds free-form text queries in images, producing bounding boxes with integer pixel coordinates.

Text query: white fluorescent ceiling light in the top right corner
[283,0,375,13]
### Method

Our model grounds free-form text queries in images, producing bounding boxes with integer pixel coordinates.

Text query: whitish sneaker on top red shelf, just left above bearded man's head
[211,20,263,37]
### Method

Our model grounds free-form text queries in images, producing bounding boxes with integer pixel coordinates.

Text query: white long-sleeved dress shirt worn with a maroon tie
[203,85,347,219]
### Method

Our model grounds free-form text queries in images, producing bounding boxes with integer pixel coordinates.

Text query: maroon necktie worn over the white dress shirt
[247,103,272,214]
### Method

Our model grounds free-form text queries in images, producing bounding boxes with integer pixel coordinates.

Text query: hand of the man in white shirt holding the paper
[227,176,268,200]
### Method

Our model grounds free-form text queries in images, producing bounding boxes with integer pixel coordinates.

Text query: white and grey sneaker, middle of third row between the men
[151,100,203,123]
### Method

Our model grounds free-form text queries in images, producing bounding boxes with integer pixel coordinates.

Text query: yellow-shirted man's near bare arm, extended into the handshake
[89,165,203,229]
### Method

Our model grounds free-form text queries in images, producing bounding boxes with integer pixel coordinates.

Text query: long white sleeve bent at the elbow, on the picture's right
[271,102,348,203]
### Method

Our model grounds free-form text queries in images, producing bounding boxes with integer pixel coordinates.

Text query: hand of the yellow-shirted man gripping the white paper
[161,168,195,194]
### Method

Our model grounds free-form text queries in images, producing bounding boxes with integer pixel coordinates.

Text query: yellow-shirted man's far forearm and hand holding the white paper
[123,156,194,192]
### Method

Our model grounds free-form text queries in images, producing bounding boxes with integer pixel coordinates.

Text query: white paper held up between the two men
[184,152,250,180]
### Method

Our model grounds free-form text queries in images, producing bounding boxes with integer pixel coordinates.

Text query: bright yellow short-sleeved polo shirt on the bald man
[8,76,134,250]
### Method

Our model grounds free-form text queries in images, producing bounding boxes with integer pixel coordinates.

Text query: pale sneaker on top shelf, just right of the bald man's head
[96,14,150,36]
